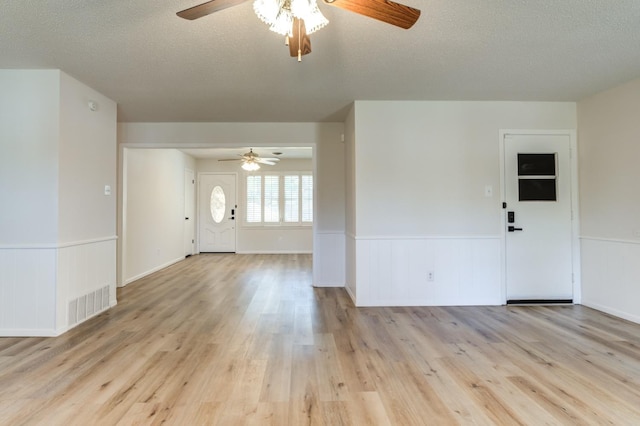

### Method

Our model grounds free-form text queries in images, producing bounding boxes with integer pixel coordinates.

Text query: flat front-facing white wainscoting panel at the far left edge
[0,247,57,336]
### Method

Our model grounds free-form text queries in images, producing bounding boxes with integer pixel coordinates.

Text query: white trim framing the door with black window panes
[499,129,582,304]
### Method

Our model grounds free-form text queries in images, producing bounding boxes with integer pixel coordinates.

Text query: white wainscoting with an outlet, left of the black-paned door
[350,236,503,306]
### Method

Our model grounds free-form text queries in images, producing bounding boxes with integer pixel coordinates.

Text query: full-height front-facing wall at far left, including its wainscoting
[0,70,60,336]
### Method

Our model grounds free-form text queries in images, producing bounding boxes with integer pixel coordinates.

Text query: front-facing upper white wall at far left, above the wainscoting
[0,70,60,247]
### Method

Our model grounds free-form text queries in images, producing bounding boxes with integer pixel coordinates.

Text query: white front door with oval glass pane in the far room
[198,173,237,253]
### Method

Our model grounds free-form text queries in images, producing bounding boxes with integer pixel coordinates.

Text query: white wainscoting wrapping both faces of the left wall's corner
[0,237,116,336]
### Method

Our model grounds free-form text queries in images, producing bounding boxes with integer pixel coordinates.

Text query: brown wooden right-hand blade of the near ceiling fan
[324,0,420,30]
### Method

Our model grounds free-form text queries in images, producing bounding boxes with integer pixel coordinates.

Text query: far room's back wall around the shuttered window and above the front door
[196,159,313,253]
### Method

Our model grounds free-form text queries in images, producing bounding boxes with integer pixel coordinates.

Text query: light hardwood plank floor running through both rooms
[0,254,640,426]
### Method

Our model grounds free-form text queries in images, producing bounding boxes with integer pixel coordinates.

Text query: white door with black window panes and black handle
[504,135,573,303]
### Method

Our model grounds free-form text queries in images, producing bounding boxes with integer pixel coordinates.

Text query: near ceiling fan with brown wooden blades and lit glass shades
[177,0,420,62]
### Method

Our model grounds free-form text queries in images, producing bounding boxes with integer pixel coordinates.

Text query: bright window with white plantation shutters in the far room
[245,172,313,226]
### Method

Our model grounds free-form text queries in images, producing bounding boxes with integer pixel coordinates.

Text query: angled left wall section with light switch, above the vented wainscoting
[58,73,117,243]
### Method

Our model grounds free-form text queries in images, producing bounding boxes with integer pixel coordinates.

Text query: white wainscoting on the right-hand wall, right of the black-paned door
[580,237,640,323]
